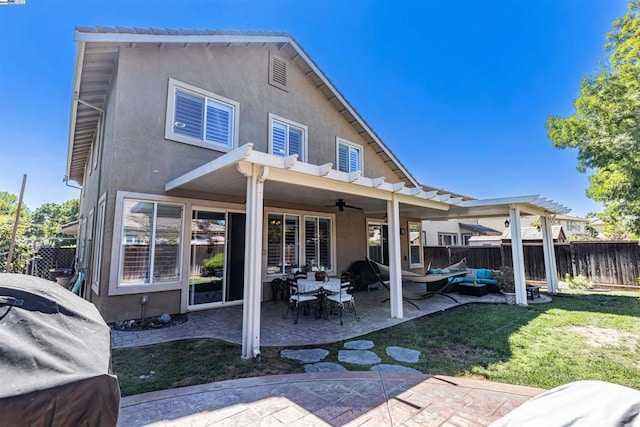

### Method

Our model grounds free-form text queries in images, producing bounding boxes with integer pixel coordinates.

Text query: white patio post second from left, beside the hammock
[387,194,404,319]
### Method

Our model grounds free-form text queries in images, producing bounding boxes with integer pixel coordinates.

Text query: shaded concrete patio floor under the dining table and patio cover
[111,284,551,348]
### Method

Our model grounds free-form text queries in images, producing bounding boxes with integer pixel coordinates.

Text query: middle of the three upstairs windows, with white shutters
[269,114,307,162]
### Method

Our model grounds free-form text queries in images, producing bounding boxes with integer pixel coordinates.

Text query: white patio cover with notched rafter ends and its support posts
[165,143,568,358]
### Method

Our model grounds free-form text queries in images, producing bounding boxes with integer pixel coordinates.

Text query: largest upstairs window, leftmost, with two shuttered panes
[165,79,239,151]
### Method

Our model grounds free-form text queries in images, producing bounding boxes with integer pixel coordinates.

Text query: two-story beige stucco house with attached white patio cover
[67,27,566,358]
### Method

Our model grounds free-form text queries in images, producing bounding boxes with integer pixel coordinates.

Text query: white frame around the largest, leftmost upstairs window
[164,78,240,152]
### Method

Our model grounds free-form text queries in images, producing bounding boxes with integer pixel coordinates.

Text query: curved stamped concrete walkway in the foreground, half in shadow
[120,372,544,426]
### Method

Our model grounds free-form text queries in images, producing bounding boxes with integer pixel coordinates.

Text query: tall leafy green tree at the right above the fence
[547,0,640,234]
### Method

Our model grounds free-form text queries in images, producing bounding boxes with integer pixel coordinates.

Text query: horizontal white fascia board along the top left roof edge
[74,30,293,44]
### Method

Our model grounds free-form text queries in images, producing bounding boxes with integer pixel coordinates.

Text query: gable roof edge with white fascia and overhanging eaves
[66,26,421,187]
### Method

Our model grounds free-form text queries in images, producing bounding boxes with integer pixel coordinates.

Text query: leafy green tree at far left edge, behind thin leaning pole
[0,191,31,272]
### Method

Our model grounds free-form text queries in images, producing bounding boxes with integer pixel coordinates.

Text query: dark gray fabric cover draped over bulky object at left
[0,274,120,426]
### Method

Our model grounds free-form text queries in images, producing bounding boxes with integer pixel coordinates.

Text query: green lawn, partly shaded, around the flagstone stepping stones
[113,291,640,396]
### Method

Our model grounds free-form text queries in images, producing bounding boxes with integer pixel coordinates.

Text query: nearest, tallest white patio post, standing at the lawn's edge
[242,164,269,359]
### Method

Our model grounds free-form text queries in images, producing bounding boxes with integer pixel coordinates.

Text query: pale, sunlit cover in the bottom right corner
[491,381,640,427]
